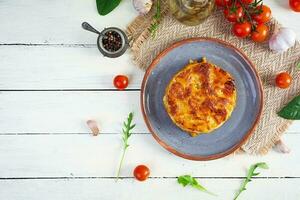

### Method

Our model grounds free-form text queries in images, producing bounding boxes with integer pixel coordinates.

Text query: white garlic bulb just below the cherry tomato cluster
[269,28,296,53]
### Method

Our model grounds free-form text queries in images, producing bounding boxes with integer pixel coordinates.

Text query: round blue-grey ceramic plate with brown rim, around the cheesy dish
[141,38,263,160]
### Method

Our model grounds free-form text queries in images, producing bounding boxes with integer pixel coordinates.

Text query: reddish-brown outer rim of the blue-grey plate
[140,37,264,161]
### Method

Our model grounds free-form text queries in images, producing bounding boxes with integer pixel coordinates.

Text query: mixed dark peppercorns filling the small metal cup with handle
[102,31,122,52]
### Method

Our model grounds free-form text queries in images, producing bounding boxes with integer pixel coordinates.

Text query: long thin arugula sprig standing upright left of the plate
[116,112,135,181]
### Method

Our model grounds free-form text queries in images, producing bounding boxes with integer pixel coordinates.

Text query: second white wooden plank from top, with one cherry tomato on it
[0,46,143,90]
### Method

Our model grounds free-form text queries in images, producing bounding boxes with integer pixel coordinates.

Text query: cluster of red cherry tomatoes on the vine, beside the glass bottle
[215,0,270,42]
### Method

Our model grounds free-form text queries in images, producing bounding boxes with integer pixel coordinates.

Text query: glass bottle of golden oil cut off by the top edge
[169,0,215,26]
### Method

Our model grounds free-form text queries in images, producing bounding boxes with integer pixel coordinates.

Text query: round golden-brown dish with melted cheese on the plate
[163,59,236,136]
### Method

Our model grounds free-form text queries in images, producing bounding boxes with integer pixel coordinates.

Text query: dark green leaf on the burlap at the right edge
[278,95,300,120]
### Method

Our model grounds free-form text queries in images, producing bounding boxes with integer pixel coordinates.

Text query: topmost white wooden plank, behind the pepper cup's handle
[0,0,300,44]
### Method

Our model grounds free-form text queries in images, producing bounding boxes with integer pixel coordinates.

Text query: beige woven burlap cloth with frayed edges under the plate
[127,1,300,154]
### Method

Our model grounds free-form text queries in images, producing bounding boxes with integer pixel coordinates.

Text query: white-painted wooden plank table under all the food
[0,0,300,200]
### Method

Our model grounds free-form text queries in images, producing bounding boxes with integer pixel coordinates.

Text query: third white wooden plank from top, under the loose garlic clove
[0,91,300,134]
